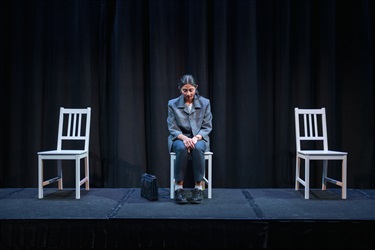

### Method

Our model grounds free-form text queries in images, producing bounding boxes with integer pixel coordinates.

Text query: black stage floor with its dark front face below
[0,188,375,249]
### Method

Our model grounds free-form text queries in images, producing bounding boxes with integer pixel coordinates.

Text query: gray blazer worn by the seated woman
[167,95,212,152]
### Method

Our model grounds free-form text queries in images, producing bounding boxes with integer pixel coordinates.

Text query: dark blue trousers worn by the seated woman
[172,140,206,182]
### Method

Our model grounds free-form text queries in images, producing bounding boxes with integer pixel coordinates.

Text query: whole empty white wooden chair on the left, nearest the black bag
[38,107,91,199]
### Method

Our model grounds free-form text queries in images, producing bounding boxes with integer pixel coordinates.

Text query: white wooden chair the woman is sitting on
[170,151,213,199]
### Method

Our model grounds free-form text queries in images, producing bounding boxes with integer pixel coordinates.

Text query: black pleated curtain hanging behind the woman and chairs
[0,0,375,188]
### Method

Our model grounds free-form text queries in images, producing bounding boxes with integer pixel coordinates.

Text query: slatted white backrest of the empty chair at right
[294,108,328,151]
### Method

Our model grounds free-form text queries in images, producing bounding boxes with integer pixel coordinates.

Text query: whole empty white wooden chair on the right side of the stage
[294,108,347,199]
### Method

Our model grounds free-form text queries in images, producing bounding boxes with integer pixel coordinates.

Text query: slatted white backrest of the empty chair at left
[57,107,91,151]
